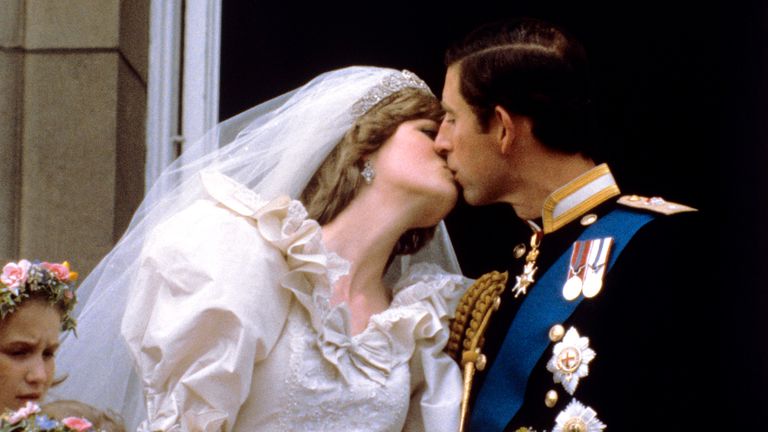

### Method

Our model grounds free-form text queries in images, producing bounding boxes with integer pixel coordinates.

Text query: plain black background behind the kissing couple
[220,0,768,430]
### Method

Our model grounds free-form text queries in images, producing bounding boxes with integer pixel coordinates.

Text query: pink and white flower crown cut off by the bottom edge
[0,402,95,432]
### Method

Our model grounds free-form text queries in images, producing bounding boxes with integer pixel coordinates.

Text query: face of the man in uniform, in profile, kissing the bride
[435,64,508,205]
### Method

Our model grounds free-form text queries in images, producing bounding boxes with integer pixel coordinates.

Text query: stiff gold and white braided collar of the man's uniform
[542,164,620,234]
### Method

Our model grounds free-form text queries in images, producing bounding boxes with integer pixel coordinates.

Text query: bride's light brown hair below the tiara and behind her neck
[300,88,443,256]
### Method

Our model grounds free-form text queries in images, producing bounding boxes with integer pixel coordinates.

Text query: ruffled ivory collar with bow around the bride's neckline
[202,173,467,384]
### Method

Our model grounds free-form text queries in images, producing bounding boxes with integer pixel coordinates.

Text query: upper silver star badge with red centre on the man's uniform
[547,327,595,394]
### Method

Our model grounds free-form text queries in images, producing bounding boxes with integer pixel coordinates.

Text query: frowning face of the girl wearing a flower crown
[0,300,61,410]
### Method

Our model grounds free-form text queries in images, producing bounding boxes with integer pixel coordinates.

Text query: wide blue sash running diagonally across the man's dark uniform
[470,209,654,432]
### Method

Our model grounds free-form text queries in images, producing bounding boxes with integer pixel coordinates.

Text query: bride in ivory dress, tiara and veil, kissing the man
[51,67,467,431]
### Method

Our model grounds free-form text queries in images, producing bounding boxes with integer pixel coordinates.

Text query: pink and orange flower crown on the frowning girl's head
[0,260,77,331]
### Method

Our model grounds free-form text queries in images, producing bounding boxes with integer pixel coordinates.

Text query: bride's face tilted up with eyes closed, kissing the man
[374,119,458,226]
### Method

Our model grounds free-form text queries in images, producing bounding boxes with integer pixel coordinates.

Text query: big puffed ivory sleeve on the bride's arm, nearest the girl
[122,200,290,431]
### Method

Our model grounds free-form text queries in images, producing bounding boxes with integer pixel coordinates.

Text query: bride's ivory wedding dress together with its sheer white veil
[49,66,462,431]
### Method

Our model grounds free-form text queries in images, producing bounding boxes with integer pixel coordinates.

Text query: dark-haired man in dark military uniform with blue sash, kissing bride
[436,19,717,432]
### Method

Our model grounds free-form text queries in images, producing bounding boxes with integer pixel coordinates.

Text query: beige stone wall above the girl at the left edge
[0,0,149,274]
